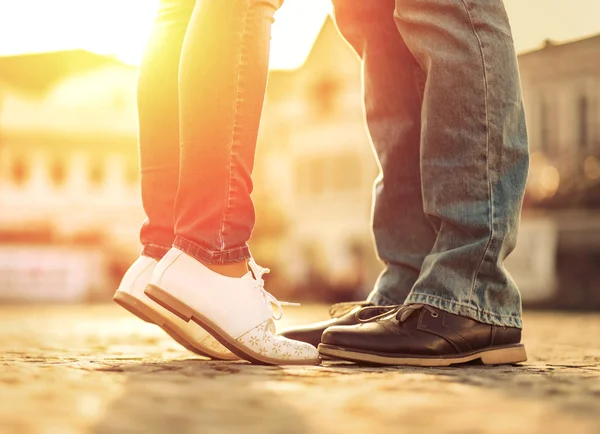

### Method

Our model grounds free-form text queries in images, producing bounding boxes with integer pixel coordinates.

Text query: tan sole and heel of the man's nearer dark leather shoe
[319,344,527,367]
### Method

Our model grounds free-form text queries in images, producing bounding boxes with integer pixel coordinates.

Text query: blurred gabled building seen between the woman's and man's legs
[255,20,381,301]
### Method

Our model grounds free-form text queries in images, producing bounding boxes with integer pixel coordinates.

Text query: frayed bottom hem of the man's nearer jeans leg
[404,292,523,329]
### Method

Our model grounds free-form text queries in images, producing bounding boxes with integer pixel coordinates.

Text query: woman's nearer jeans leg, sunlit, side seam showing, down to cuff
[174,0,281,267]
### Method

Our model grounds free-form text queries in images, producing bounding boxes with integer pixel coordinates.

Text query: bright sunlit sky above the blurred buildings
[0,0,600,68]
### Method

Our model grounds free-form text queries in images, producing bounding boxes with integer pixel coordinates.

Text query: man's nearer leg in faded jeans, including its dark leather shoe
[319,0,528,366]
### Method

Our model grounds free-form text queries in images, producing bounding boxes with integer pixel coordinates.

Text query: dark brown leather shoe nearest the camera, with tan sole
[319,304,527,366]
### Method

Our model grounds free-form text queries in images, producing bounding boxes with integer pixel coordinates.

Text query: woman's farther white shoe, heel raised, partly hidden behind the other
[113,256,239,360]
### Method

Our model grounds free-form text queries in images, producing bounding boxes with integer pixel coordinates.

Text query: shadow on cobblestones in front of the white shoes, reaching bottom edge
[90,359,314,434]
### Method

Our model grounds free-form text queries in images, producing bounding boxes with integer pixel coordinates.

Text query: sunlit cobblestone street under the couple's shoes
[0,305,600,434]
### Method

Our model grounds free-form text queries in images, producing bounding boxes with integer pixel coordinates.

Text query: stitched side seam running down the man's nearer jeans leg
[461,0,494,301]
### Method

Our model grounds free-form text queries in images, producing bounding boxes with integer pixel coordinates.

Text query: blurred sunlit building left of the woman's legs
[0,51,143,299]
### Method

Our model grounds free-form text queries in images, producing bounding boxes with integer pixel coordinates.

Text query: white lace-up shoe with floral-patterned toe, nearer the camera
[145,248,320,365]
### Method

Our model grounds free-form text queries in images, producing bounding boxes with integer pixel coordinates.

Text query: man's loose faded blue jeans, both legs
[333,0,529,328]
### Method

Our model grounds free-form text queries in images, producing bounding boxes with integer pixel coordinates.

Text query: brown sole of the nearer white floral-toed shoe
[144,284,321,365]
